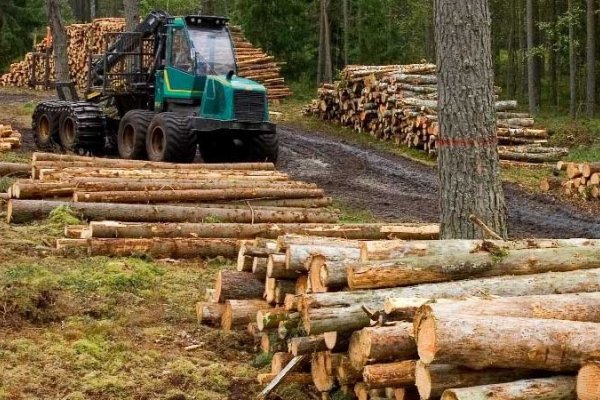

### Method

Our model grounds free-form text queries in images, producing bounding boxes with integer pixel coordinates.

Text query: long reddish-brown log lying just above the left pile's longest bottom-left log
[73,188,324,203]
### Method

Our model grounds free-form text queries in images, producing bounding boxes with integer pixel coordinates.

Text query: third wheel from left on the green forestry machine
[117,110,155,160]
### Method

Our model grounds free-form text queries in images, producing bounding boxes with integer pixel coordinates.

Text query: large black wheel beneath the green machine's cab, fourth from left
[146,112,197,163]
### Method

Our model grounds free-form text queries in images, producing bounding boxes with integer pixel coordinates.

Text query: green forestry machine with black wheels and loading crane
[32,11,278,163]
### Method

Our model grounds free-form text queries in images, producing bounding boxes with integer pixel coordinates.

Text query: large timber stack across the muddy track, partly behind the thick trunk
[304,64,568,163]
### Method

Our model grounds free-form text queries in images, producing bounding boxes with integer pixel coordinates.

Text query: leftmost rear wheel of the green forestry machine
[31,101,66,150]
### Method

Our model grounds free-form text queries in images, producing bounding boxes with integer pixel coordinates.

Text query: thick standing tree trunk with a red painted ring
[435,0,508,239]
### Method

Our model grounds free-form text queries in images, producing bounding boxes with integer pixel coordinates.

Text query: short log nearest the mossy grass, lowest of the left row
[70,238,238,258]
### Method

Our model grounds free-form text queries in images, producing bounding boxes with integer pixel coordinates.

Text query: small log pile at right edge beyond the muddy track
[540,161,600,200]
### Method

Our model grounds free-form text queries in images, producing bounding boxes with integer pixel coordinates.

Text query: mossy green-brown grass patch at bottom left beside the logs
[0,216,314,400]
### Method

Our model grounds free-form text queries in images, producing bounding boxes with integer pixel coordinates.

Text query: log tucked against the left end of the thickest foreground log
[348,322,417,370]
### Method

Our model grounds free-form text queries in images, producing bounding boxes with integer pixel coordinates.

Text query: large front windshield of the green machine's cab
[189,28,235,75]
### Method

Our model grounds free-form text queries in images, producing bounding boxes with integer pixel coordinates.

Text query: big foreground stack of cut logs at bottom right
[196,234,600,400]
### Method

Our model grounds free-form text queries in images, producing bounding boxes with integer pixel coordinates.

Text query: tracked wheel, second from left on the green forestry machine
[58,101,104,153]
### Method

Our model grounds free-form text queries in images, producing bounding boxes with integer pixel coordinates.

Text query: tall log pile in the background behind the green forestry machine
[0,18,292,100]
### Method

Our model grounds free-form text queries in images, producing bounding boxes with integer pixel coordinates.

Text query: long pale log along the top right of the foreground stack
[348,247,600,289]
